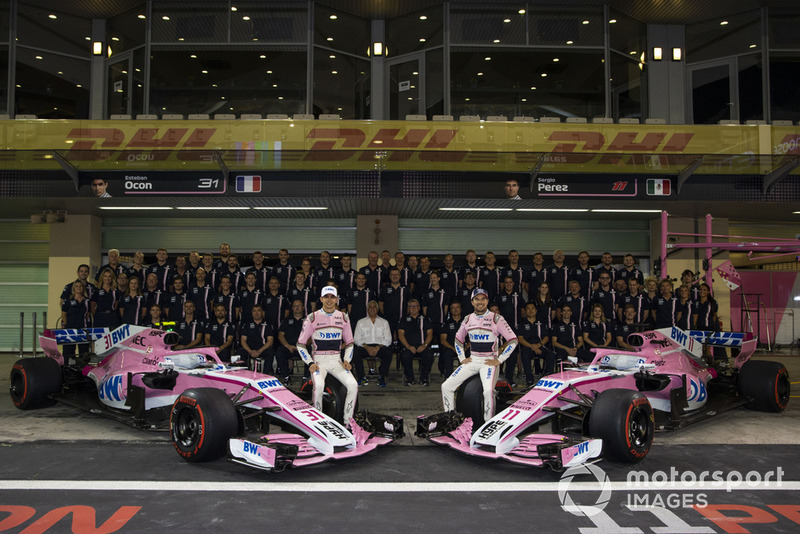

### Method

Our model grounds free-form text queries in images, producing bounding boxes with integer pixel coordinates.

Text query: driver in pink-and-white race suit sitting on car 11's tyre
[442,289,518,421]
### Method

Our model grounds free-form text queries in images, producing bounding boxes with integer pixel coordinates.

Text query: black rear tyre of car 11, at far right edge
[737,360,792,412]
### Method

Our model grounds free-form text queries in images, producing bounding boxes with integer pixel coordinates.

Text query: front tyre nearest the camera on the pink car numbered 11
[589,389,655,463]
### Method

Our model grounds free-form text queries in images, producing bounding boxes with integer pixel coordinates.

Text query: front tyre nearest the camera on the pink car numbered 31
[169,388,239,462]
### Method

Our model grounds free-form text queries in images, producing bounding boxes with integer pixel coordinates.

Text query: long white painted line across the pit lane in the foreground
[0,480,800,493]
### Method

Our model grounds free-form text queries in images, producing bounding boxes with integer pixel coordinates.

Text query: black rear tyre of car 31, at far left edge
[10,358,64,410]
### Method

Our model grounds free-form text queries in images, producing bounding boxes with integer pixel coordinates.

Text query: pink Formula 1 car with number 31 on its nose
[11,325,403,471]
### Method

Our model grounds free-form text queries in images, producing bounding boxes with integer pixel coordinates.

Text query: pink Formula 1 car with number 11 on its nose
[416,328,791,469]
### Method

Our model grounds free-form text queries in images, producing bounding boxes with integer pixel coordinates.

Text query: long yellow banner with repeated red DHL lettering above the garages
[0,120,800,174]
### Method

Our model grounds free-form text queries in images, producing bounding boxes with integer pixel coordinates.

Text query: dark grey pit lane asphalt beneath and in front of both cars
[0,356,800,533]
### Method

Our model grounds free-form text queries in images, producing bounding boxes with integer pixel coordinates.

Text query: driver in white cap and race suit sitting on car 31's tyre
[297,286,358,425]
